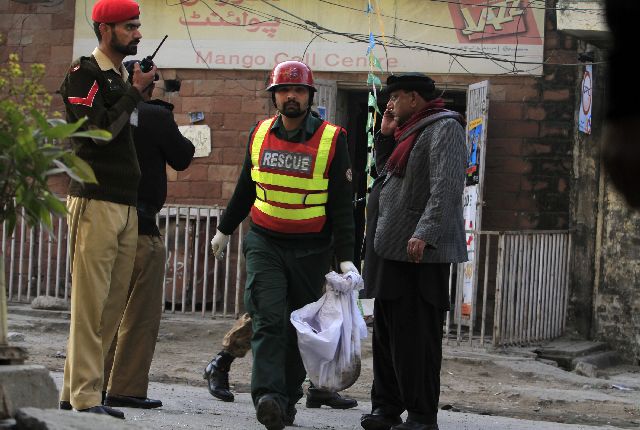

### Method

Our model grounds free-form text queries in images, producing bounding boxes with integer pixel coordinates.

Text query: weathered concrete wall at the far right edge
[567,42,640,362]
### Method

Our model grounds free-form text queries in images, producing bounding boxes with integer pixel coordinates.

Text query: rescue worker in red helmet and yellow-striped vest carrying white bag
[211,61,358,430]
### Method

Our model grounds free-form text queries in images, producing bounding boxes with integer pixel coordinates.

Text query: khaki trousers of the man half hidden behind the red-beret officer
[104,235,166,397]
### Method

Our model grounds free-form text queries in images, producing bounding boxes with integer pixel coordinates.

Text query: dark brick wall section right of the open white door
[482,10,576,230]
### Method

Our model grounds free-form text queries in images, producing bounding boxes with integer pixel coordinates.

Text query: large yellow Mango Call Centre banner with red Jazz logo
[74,0,544,75]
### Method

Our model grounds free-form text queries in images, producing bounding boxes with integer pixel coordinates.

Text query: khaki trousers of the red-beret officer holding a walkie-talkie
[60,196,138,409]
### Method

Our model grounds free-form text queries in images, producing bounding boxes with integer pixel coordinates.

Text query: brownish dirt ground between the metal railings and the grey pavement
[9,305,640,428]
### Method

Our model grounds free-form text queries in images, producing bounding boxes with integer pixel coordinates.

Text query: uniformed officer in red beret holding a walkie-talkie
[60,0,155,418]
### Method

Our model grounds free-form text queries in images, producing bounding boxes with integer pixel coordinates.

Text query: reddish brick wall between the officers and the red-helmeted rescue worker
[156,69,271,205]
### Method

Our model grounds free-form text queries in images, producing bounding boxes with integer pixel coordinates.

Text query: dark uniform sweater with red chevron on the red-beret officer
[60,48,142,206]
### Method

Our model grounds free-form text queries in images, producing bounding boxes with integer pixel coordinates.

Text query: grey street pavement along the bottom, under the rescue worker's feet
[51,372,618,430]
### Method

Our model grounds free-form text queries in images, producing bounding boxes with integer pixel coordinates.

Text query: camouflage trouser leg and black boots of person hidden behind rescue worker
[203,313,358,409]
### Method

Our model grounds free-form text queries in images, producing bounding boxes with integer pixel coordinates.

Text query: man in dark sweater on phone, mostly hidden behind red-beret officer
[104,60,195,409]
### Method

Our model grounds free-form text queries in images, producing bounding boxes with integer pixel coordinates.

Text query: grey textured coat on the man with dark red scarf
[374,118,468,263]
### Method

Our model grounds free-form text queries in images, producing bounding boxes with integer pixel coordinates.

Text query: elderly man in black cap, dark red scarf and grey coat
[361,73,468,430]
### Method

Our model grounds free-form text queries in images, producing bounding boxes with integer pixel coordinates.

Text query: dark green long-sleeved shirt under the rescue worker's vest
[218,115,354,261]
